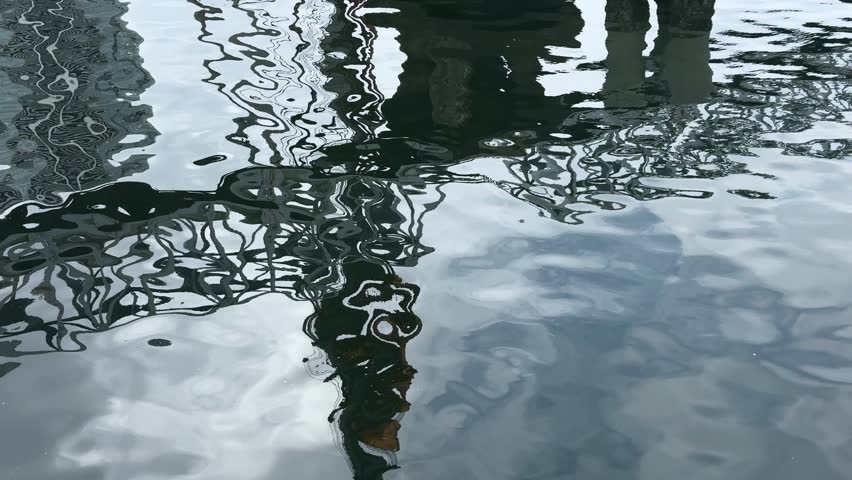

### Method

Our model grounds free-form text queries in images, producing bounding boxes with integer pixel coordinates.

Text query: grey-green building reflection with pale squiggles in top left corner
[0,0,156,209]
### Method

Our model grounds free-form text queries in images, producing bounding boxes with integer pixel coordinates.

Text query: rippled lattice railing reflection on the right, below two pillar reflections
[466,66,852,223]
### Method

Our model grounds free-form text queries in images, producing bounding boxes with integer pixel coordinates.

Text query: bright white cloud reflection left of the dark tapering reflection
[48,295,348,479]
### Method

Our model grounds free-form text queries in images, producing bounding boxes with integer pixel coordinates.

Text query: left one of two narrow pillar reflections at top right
[603,0,650,108]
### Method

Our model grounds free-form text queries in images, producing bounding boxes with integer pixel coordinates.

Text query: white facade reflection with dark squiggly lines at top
[192,0,353,165]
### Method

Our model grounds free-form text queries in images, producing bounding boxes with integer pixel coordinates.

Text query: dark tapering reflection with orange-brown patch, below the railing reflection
[305,268,422,480]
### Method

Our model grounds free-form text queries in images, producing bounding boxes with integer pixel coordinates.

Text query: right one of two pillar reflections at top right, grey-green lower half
[654,0,714,104]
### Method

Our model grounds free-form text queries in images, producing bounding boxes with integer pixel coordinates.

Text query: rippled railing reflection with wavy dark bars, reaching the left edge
[0,161,446,353]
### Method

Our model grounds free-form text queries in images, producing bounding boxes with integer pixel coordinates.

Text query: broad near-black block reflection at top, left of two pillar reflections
[364,0,583,154]
